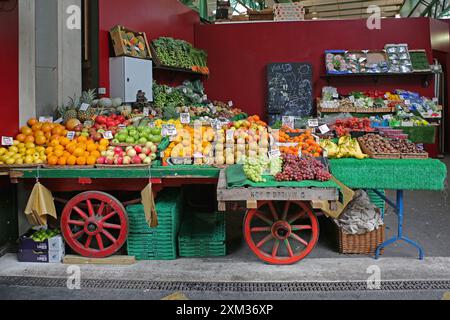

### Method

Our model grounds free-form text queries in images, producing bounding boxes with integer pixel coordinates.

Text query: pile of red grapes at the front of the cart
[275,154,331,181]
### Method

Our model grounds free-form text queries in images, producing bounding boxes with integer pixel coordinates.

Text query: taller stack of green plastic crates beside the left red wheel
[127,189,183,260]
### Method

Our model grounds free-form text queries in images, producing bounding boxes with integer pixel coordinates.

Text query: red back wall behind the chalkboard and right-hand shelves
[195,18,433,115]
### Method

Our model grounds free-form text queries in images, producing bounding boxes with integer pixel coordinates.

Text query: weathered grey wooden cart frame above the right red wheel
[217,170,339,211]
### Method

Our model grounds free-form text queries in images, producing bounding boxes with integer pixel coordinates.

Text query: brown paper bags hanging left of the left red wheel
[25,182,57,226]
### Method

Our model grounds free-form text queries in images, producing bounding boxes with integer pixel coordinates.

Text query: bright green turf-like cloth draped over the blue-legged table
[330,159,447,191]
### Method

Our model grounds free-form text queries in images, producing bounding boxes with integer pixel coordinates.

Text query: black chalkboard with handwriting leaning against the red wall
[267,63,313,117]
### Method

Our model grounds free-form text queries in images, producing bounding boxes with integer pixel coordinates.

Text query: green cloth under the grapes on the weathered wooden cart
[226,164,339,189]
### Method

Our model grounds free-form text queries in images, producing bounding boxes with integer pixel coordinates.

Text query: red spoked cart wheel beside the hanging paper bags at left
[61,191,128,258]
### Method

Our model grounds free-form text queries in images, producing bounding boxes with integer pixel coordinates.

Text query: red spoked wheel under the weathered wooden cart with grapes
[244,201,319,264]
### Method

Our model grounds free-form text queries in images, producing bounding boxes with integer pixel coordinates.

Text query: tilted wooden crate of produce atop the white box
[109,25,152,59]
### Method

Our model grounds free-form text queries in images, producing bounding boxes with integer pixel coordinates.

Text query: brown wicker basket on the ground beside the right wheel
[336,225,385,254]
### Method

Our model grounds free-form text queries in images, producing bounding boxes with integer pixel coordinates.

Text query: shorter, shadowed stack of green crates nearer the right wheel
[178,213,226,257]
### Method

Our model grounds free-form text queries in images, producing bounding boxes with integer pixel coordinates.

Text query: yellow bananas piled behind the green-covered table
[320,136,368,159]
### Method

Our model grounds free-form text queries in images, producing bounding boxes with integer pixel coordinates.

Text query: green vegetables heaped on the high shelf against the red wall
[152,37,209,74]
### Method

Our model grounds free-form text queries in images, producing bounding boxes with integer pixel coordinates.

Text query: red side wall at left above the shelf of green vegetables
[99,0,199,95]
